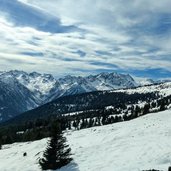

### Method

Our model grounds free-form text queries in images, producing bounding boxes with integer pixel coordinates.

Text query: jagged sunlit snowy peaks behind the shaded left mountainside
[0,70,138,99]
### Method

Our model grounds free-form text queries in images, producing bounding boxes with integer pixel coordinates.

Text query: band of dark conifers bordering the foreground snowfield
[0,93,171,144]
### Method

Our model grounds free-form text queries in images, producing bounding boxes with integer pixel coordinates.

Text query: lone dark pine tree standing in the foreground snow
[39,123,72,170]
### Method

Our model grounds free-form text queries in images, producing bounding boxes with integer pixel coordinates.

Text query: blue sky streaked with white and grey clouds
[0,0,171,79]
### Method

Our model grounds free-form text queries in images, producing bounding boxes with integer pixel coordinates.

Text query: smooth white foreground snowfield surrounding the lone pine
[0,110,171,171]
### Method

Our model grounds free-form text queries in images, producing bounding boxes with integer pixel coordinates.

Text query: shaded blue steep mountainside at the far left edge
[0,75,39,122]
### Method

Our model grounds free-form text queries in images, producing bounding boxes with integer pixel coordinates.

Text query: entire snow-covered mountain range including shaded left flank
[0,70,137,121]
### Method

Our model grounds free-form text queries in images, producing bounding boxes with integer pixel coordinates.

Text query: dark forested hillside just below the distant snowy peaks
[3,91,159,125]
